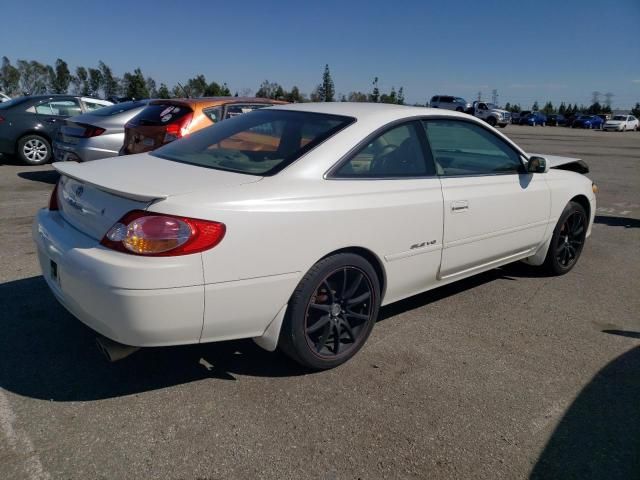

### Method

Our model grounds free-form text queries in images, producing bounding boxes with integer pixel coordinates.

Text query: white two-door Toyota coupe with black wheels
[33,103,596,369]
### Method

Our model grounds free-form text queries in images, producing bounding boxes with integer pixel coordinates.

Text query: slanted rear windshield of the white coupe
[152,110,355,176]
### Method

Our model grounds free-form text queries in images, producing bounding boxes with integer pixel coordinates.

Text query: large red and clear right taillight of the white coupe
[100,210,226,257]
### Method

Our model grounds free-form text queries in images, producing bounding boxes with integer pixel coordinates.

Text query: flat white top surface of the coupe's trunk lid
[53,153,262,201]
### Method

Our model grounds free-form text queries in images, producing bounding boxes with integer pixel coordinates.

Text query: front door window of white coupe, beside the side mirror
[423,120,522,176]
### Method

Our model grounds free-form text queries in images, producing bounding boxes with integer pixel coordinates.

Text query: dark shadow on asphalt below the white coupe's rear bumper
[0,277,309,402]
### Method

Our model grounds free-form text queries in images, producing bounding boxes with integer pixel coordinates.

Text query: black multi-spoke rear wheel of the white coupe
[278,253,380,370]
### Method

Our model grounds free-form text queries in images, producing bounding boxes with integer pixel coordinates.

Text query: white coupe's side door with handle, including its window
[423,119,551,279]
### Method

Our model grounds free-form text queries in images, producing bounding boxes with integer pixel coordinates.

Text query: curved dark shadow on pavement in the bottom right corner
[530,346,640,480]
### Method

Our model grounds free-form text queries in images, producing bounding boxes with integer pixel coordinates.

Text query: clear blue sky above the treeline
[0,0,640,107]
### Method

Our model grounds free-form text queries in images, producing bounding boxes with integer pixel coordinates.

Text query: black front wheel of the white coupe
[544,202,589,275]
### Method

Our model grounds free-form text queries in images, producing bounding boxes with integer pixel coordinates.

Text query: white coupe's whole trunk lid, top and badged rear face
[53,154,262,240]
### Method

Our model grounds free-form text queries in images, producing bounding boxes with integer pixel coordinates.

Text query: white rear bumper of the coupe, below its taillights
[33,209,204,347]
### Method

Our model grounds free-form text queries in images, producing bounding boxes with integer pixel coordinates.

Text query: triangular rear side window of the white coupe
[334,122,435,178]
